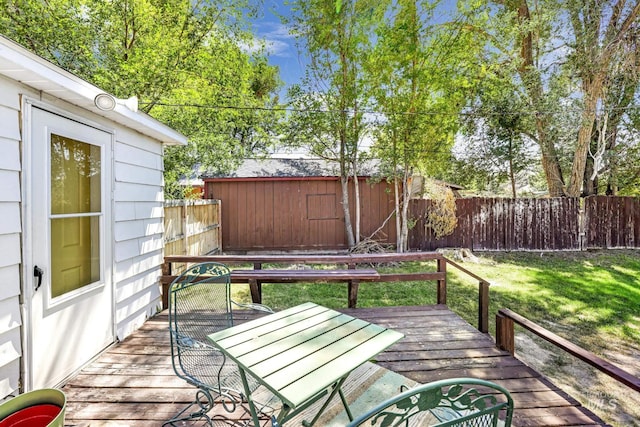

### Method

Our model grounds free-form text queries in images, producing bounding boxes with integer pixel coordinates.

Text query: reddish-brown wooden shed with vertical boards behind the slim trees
[202,159,396,252]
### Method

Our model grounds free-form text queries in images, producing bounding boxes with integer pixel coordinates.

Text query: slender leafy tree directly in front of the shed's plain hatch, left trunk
[289,0,382,247]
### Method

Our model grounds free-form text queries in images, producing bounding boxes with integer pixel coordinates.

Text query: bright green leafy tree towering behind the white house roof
[0,0,280,196]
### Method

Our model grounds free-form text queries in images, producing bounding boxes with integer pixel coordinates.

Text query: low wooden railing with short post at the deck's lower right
[496,309,640,391]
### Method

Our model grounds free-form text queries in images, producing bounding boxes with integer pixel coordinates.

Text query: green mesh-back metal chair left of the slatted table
[163,262,273,427]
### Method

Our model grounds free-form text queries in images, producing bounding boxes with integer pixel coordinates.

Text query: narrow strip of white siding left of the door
[0,77,23,400]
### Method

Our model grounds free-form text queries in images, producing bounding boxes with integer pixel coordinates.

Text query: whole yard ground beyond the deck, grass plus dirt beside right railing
[234,250,640,427]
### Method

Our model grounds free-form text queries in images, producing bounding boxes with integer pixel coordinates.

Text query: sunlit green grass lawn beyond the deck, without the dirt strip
[240,250,640,348]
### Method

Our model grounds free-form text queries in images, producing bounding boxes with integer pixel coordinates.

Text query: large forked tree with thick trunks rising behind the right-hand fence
[488,0,640,197]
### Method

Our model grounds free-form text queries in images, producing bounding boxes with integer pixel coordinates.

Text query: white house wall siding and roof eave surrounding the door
[0,35,187,402]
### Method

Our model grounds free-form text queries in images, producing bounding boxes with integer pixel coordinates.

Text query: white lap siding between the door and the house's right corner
[114,129,164,339]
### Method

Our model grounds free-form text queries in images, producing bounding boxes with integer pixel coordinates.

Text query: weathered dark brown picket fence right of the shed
[409,196,640,251]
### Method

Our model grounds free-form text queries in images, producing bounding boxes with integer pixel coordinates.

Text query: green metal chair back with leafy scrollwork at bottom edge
[347,378,513,427]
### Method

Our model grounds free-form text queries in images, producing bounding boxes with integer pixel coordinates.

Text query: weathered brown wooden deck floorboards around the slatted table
[63,306,606,427]
